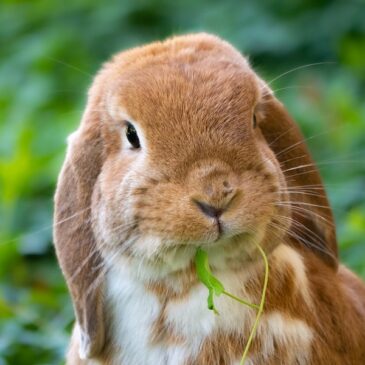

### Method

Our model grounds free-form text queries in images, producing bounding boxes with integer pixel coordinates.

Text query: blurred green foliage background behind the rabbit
[0,0,365,365]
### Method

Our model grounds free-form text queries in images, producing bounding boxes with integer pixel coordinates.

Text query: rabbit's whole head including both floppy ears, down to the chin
[55,34,337,357]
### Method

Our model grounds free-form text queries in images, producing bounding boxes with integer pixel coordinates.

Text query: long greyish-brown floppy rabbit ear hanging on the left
[54,103,104,358]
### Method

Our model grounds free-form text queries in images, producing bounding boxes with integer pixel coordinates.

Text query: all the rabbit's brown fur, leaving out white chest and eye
[54,34,365,365]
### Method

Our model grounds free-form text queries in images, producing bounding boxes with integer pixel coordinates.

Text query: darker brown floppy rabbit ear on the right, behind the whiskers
[259,91,338,268]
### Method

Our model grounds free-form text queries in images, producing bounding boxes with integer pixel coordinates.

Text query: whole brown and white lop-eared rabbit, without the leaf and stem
[54,34,365,365]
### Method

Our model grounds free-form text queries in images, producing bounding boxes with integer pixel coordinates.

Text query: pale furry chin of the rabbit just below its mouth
[106,230,265,282]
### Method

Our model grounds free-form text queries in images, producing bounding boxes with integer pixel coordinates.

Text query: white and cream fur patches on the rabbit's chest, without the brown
[106,243,313,365]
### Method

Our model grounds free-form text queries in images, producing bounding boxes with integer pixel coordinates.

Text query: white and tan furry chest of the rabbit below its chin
[102,245,312,365]
